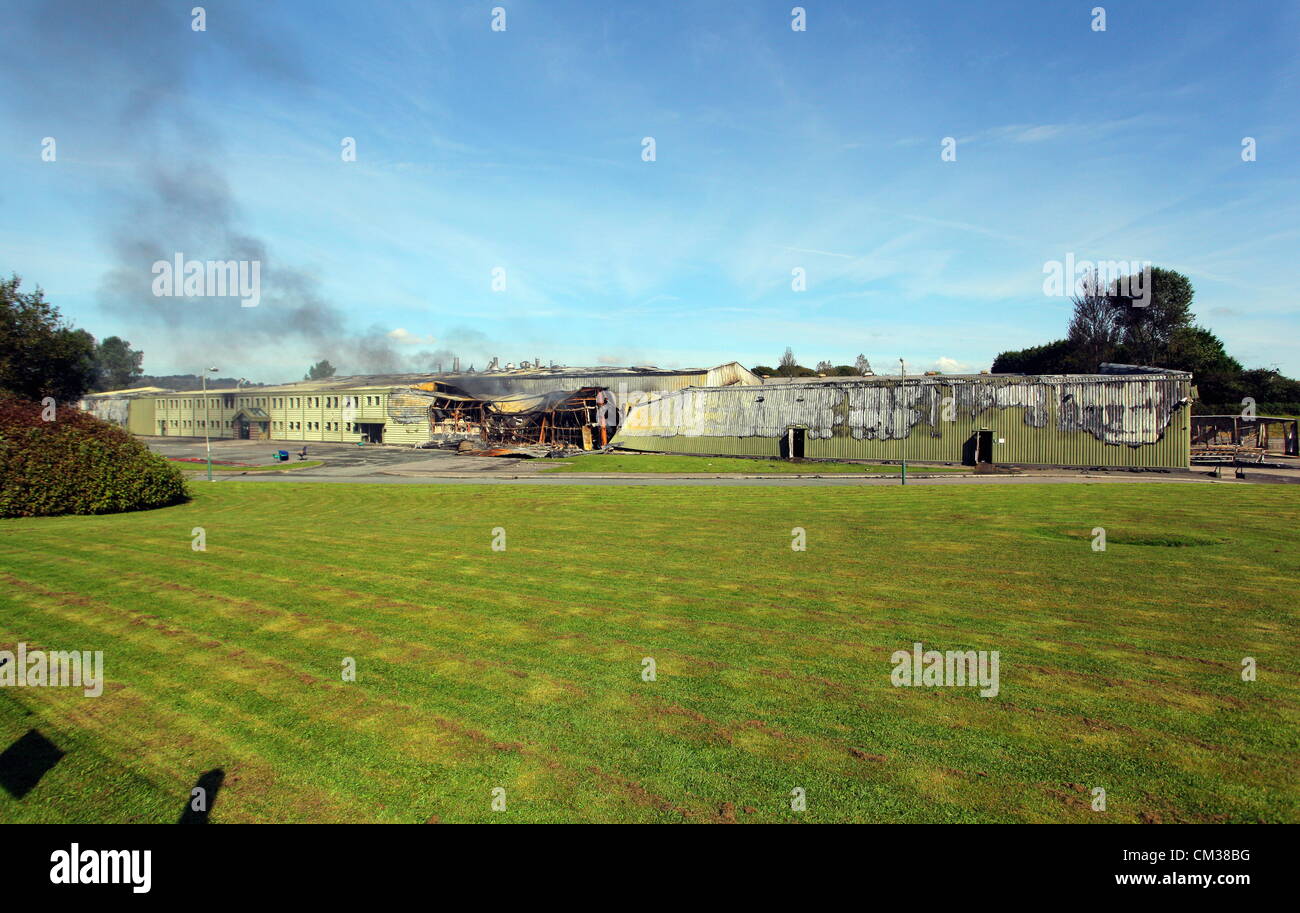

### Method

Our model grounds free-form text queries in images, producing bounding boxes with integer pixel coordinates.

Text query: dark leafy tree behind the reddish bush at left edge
[0,276,96,402]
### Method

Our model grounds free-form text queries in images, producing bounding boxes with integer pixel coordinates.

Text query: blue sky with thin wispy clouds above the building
[0,0,1300,381]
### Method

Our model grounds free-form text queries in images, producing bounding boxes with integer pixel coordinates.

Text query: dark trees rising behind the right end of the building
[993,268,1300,414]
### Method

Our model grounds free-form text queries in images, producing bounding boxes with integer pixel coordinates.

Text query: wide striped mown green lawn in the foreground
[0,483,1300,822]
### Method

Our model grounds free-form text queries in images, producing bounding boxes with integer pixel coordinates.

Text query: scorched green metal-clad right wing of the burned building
[614,365,1192,468]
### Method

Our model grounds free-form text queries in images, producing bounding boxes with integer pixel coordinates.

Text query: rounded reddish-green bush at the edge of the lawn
[0,394,187,516]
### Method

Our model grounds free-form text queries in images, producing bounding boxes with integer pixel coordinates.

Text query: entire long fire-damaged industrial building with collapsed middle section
[83,362,1195,468]
